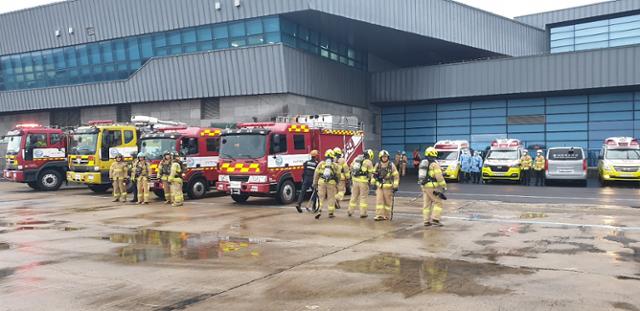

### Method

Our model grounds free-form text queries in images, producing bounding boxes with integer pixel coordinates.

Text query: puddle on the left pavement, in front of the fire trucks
[103,229,268,263]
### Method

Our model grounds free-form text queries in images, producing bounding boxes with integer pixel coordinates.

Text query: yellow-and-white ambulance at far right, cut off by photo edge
[598,137,640,186]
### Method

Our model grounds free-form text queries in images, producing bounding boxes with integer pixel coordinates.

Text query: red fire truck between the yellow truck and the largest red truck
[140,127,222,199]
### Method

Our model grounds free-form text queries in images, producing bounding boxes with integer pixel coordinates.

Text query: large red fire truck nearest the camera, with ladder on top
[217,115,364,204]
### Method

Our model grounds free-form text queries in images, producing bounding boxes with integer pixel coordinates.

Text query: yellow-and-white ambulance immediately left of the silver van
[482,139,524,182]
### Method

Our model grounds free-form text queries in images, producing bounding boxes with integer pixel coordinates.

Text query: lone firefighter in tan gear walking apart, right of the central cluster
[418,147,447,227]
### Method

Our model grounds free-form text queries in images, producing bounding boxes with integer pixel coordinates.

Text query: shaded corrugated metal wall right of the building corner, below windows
[284,47,368,107]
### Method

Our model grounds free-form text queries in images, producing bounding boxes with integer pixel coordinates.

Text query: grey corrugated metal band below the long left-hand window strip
[0,45,287,112]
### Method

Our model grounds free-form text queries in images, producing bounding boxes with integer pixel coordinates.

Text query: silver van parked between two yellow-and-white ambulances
[545,147,588,187]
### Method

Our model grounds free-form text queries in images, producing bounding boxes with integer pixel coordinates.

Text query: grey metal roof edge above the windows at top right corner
[515,0,640,29]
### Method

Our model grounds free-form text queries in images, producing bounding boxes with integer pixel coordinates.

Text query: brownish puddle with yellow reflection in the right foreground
[337,253,535,298]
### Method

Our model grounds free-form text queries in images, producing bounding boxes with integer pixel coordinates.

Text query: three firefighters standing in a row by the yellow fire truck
[109,152,184,207]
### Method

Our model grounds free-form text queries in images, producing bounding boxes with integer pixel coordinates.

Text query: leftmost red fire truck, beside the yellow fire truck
[3,124,67,191]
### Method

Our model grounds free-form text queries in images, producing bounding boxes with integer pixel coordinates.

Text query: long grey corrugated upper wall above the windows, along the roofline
[0,0,546,56]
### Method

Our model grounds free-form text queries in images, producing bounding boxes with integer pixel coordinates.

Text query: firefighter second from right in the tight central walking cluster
[348,149,374,218]
